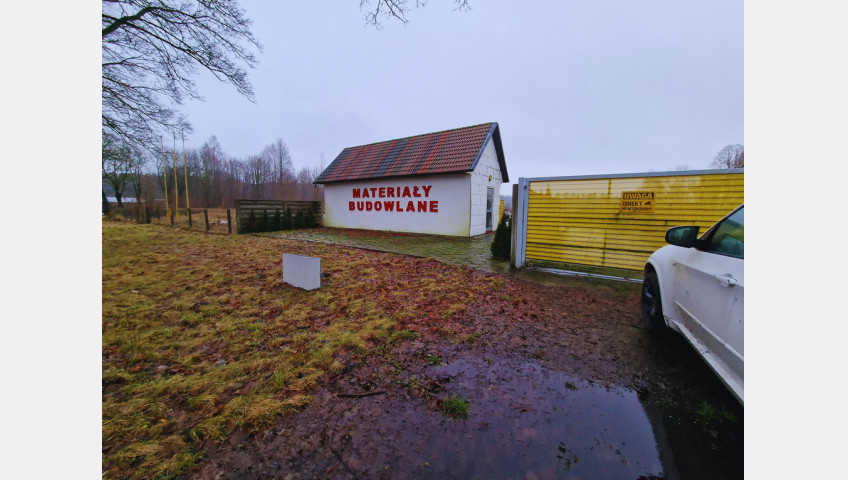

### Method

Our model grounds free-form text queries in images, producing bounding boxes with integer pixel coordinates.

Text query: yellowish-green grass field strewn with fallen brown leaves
[102,222,502,479]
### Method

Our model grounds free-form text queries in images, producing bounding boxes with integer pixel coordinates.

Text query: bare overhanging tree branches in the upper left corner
[101,0,262,151]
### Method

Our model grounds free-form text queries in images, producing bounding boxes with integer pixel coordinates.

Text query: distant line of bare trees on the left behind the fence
[102,135,323,208]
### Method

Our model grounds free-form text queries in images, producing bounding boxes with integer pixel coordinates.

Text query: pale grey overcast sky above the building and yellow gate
[182,0,744,193]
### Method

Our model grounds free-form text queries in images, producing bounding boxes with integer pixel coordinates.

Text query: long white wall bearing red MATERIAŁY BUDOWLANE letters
[324,175,470,236]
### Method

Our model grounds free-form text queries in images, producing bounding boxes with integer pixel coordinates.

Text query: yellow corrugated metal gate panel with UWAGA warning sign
[526,173,745,270]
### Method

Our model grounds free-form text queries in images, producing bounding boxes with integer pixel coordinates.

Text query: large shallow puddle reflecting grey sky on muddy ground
[416,360,676,480]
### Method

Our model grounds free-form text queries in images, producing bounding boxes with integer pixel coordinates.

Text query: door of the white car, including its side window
[673,207,745,380]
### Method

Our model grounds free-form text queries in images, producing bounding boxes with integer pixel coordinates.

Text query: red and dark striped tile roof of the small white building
[315,122,509,183]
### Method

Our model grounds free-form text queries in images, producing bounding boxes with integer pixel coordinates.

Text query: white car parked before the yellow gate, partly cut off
[641,205,745,404]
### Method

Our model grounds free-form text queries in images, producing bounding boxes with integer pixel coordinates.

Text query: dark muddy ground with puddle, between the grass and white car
[191,268,743,480]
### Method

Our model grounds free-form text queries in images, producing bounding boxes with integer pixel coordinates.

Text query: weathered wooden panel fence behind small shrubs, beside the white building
[236,200,324,233]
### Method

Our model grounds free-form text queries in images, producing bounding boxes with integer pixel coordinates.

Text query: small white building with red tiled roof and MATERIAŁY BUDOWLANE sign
[314,122,509,237]
